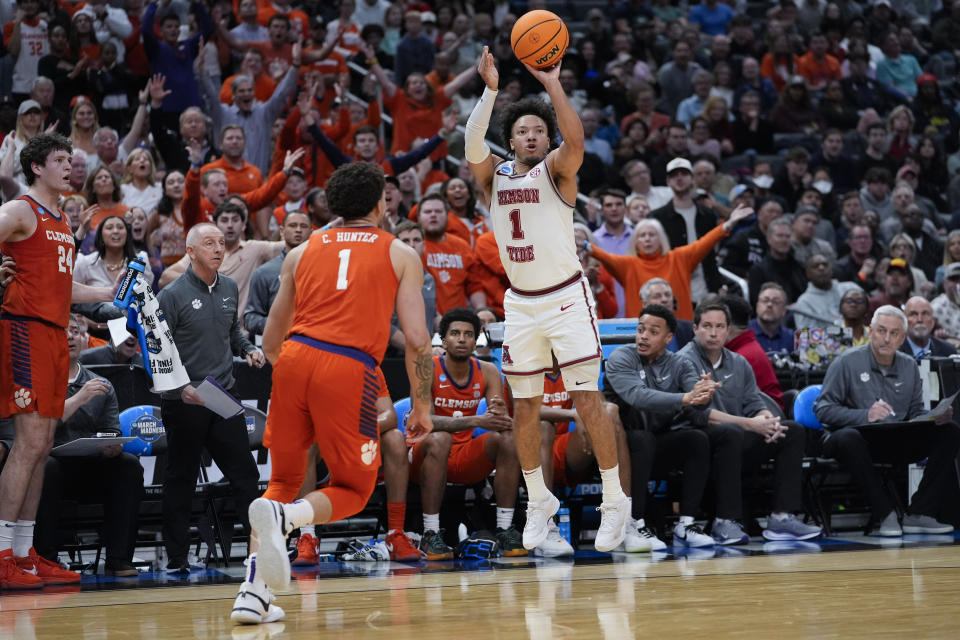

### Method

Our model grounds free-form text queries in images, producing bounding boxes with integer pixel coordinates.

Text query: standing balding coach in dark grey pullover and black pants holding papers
[159,223,264,573]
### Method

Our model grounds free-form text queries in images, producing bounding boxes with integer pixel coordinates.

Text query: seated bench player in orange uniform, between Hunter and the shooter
[410,308,527,560]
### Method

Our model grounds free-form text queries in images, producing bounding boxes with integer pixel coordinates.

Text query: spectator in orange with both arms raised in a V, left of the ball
[363,45,477,154]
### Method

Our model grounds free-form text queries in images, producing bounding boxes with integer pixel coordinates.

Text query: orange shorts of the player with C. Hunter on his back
[263,335,380,521]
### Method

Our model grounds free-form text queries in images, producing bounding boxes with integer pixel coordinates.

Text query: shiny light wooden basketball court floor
[0,537,960,640]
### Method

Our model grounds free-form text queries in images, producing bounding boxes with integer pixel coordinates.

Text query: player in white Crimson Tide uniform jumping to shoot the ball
[465,47,630,551]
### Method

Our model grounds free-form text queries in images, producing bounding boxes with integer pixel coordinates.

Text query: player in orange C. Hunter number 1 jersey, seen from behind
[231,162,433,624]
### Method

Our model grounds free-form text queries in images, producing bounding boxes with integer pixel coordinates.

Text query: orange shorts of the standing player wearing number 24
[0,317,70,419]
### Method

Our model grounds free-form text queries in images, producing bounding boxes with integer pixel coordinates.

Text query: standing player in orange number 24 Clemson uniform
[0,134,113,589]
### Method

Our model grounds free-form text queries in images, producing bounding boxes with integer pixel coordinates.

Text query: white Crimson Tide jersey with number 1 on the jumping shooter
[490,161,580,291]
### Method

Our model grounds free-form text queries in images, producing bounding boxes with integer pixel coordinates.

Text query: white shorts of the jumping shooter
[502,274,603,398]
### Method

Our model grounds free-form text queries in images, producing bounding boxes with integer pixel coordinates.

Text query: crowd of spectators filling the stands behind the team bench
[0,0,960,564]
